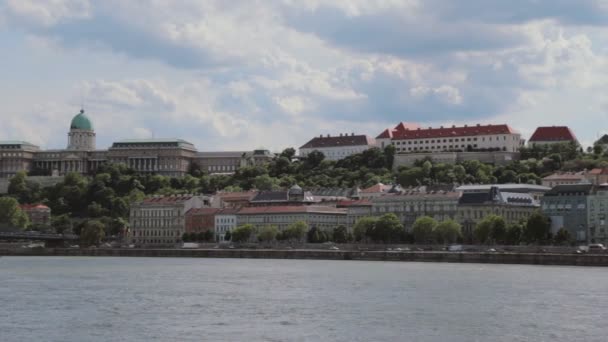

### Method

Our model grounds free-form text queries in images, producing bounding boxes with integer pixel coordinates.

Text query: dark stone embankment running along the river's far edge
[0,248,608,266]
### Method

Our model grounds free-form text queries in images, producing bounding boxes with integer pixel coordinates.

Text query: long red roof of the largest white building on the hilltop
[384,124,517,140]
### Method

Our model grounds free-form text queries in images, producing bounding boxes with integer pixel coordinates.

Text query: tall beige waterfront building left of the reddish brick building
[129,195,210,246]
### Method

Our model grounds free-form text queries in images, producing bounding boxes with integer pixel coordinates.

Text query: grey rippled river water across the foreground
[0,257,608,342]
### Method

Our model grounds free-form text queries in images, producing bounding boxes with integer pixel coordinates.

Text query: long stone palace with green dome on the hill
[0,110,273,178]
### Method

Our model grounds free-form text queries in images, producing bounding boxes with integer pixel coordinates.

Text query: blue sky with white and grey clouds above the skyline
[0,0,608,151]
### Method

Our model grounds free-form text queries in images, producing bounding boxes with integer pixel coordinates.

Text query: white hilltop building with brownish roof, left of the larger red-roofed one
[300,133,376,160]
